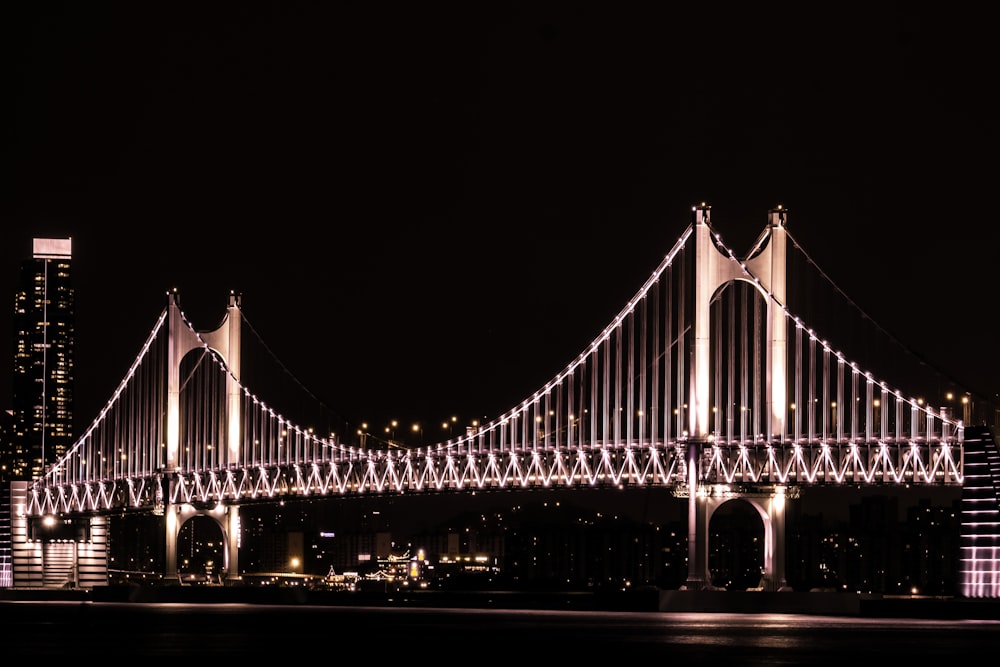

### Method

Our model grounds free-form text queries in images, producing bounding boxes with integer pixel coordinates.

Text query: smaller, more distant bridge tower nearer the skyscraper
[163,291,242,582]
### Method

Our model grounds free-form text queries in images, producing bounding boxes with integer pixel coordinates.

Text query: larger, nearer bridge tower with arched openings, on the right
[685,204,787,590]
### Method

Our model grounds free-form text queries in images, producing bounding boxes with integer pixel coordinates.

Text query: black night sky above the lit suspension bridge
[0,3,1000,470]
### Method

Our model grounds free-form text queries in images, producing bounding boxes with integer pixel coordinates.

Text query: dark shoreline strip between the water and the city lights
[0,585,1000,620]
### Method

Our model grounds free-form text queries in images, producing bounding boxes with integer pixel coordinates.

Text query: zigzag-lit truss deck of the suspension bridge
[28,440,962,516]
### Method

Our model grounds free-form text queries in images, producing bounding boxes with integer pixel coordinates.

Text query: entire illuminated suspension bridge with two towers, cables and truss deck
[0,205,1000,597]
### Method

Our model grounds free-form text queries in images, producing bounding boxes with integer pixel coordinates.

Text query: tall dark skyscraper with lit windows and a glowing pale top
[2,238,75,480]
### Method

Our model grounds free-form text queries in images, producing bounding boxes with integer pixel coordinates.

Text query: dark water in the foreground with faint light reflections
[7,601,1000,667]
